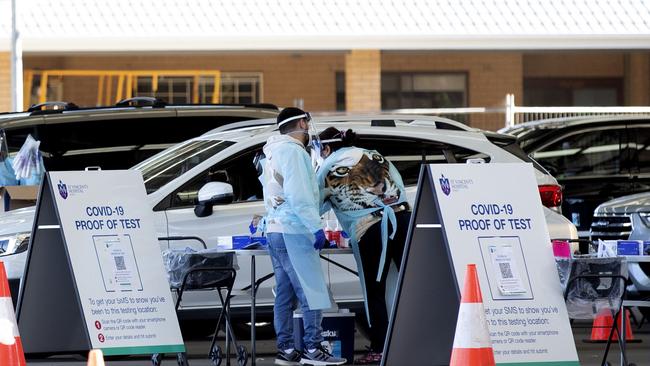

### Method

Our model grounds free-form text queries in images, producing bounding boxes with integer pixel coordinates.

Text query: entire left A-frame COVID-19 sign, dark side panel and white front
[16,171,187,365]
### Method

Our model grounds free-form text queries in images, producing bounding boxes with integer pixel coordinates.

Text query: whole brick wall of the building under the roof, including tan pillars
[20,50,650,130]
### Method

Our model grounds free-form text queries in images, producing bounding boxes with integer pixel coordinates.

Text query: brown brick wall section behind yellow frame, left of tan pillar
[24,52,344,111]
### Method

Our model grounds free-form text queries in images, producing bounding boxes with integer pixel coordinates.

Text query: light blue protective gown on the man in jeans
[260,135,331,310]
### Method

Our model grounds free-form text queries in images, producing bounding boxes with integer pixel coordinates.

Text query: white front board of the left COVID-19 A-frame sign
[49,171,185,355]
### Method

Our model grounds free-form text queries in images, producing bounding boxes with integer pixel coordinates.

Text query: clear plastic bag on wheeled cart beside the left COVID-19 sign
[162,248,239,289]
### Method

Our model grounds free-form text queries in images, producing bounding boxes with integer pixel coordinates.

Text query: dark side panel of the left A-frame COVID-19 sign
[16,174,92,353]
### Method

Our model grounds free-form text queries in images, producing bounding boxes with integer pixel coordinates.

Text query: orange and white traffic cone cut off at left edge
[0,262,26,366]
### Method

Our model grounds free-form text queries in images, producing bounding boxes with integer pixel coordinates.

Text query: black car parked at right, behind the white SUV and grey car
[500,115,650,238]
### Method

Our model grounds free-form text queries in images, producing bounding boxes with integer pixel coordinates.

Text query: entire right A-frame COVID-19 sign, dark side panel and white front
[382,163,579,366]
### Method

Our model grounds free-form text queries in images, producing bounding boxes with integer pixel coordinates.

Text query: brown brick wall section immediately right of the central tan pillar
[381,52,523,130]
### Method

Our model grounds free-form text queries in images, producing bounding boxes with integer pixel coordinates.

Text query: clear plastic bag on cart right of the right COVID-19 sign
[566,257,627,319]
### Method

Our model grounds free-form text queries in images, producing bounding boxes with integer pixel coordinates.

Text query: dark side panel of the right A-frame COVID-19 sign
[381,165,460,366]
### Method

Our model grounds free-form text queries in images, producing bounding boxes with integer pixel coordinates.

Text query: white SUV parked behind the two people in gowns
[0,115,577,315]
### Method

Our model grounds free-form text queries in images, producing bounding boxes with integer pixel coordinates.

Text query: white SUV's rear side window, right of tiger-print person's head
[357,135,490,186]
